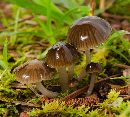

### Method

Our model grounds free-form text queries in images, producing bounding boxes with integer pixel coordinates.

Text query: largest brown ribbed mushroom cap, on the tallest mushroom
[67,16,112,51]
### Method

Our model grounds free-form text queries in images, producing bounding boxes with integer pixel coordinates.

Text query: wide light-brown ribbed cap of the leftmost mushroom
[14,59,54,84]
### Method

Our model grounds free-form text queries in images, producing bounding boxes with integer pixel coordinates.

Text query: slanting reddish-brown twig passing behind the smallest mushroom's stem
[62,74,119,100]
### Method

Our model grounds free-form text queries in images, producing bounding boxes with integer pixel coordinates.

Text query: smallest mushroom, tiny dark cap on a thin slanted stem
[86,62,102,95]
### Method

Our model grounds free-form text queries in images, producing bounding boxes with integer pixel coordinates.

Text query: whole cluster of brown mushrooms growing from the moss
[14,16,112,98]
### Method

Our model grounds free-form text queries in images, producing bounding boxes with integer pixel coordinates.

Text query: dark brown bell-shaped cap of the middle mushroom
[46,42,76,68]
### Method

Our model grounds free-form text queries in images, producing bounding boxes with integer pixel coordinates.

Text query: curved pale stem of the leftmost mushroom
[36,82,58,98]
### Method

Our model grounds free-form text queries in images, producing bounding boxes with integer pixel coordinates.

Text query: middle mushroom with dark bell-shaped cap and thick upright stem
[46,42,76,91]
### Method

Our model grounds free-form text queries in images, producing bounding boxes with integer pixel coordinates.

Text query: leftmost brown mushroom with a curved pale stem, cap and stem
[14,59,58,98]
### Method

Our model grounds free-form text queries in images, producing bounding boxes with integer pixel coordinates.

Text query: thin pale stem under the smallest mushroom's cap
[87,73,96,95]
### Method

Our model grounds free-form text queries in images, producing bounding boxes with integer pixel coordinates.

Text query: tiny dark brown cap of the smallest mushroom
[86,62,102,73]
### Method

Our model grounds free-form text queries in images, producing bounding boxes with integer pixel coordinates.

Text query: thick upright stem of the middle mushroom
[59,67,69,91]
